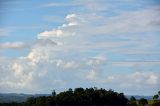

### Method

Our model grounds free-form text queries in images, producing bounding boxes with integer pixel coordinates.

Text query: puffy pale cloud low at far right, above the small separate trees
[117,72,160,90]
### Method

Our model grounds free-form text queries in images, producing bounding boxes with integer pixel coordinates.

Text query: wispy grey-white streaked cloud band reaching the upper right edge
[77,7,159,36]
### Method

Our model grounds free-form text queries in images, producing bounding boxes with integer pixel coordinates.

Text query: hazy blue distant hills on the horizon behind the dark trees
[0,93,152,103]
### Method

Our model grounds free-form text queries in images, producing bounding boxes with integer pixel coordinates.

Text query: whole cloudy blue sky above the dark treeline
[0,0,160,95]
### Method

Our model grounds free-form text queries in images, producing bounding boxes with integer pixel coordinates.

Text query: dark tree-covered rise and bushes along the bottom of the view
[0,88,160,106]
